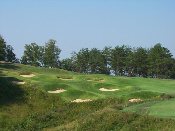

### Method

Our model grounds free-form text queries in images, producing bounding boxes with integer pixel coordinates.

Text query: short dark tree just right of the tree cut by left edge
[5,45,16,62]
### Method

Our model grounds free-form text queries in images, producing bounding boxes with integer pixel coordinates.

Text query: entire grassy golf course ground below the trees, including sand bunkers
[0,61,175,130]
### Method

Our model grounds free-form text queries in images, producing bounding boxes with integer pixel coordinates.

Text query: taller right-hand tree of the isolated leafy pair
[43,39,61,68]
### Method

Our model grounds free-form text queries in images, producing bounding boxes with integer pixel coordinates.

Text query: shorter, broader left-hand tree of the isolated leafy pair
[21,43,44,66]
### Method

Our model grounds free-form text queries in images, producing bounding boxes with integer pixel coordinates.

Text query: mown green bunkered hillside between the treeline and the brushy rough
[0,63,175,102]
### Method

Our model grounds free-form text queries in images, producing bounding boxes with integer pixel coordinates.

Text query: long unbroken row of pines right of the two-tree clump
[61,44,175,78]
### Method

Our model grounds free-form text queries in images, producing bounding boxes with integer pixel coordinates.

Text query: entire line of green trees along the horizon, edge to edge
[0,36,175,78]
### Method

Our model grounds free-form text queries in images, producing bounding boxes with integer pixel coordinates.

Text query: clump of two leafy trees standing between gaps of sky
[21,39,61,68]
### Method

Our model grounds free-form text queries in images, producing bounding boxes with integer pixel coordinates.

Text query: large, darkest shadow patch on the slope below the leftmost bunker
[0,74,25,106]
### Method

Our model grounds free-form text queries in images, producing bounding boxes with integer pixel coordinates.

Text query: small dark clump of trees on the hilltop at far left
[0,35,19,63]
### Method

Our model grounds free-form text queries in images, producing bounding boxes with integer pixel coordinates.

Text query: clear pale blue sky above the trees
[0,0,175,59]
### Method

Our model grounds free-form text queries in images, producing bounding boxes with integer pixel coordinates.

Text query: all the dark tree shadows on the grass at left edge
[0,62,25,106]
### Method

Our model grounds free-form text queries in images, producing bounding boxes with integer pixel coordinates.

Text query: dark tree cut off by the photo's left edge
[0,35,6,61]
